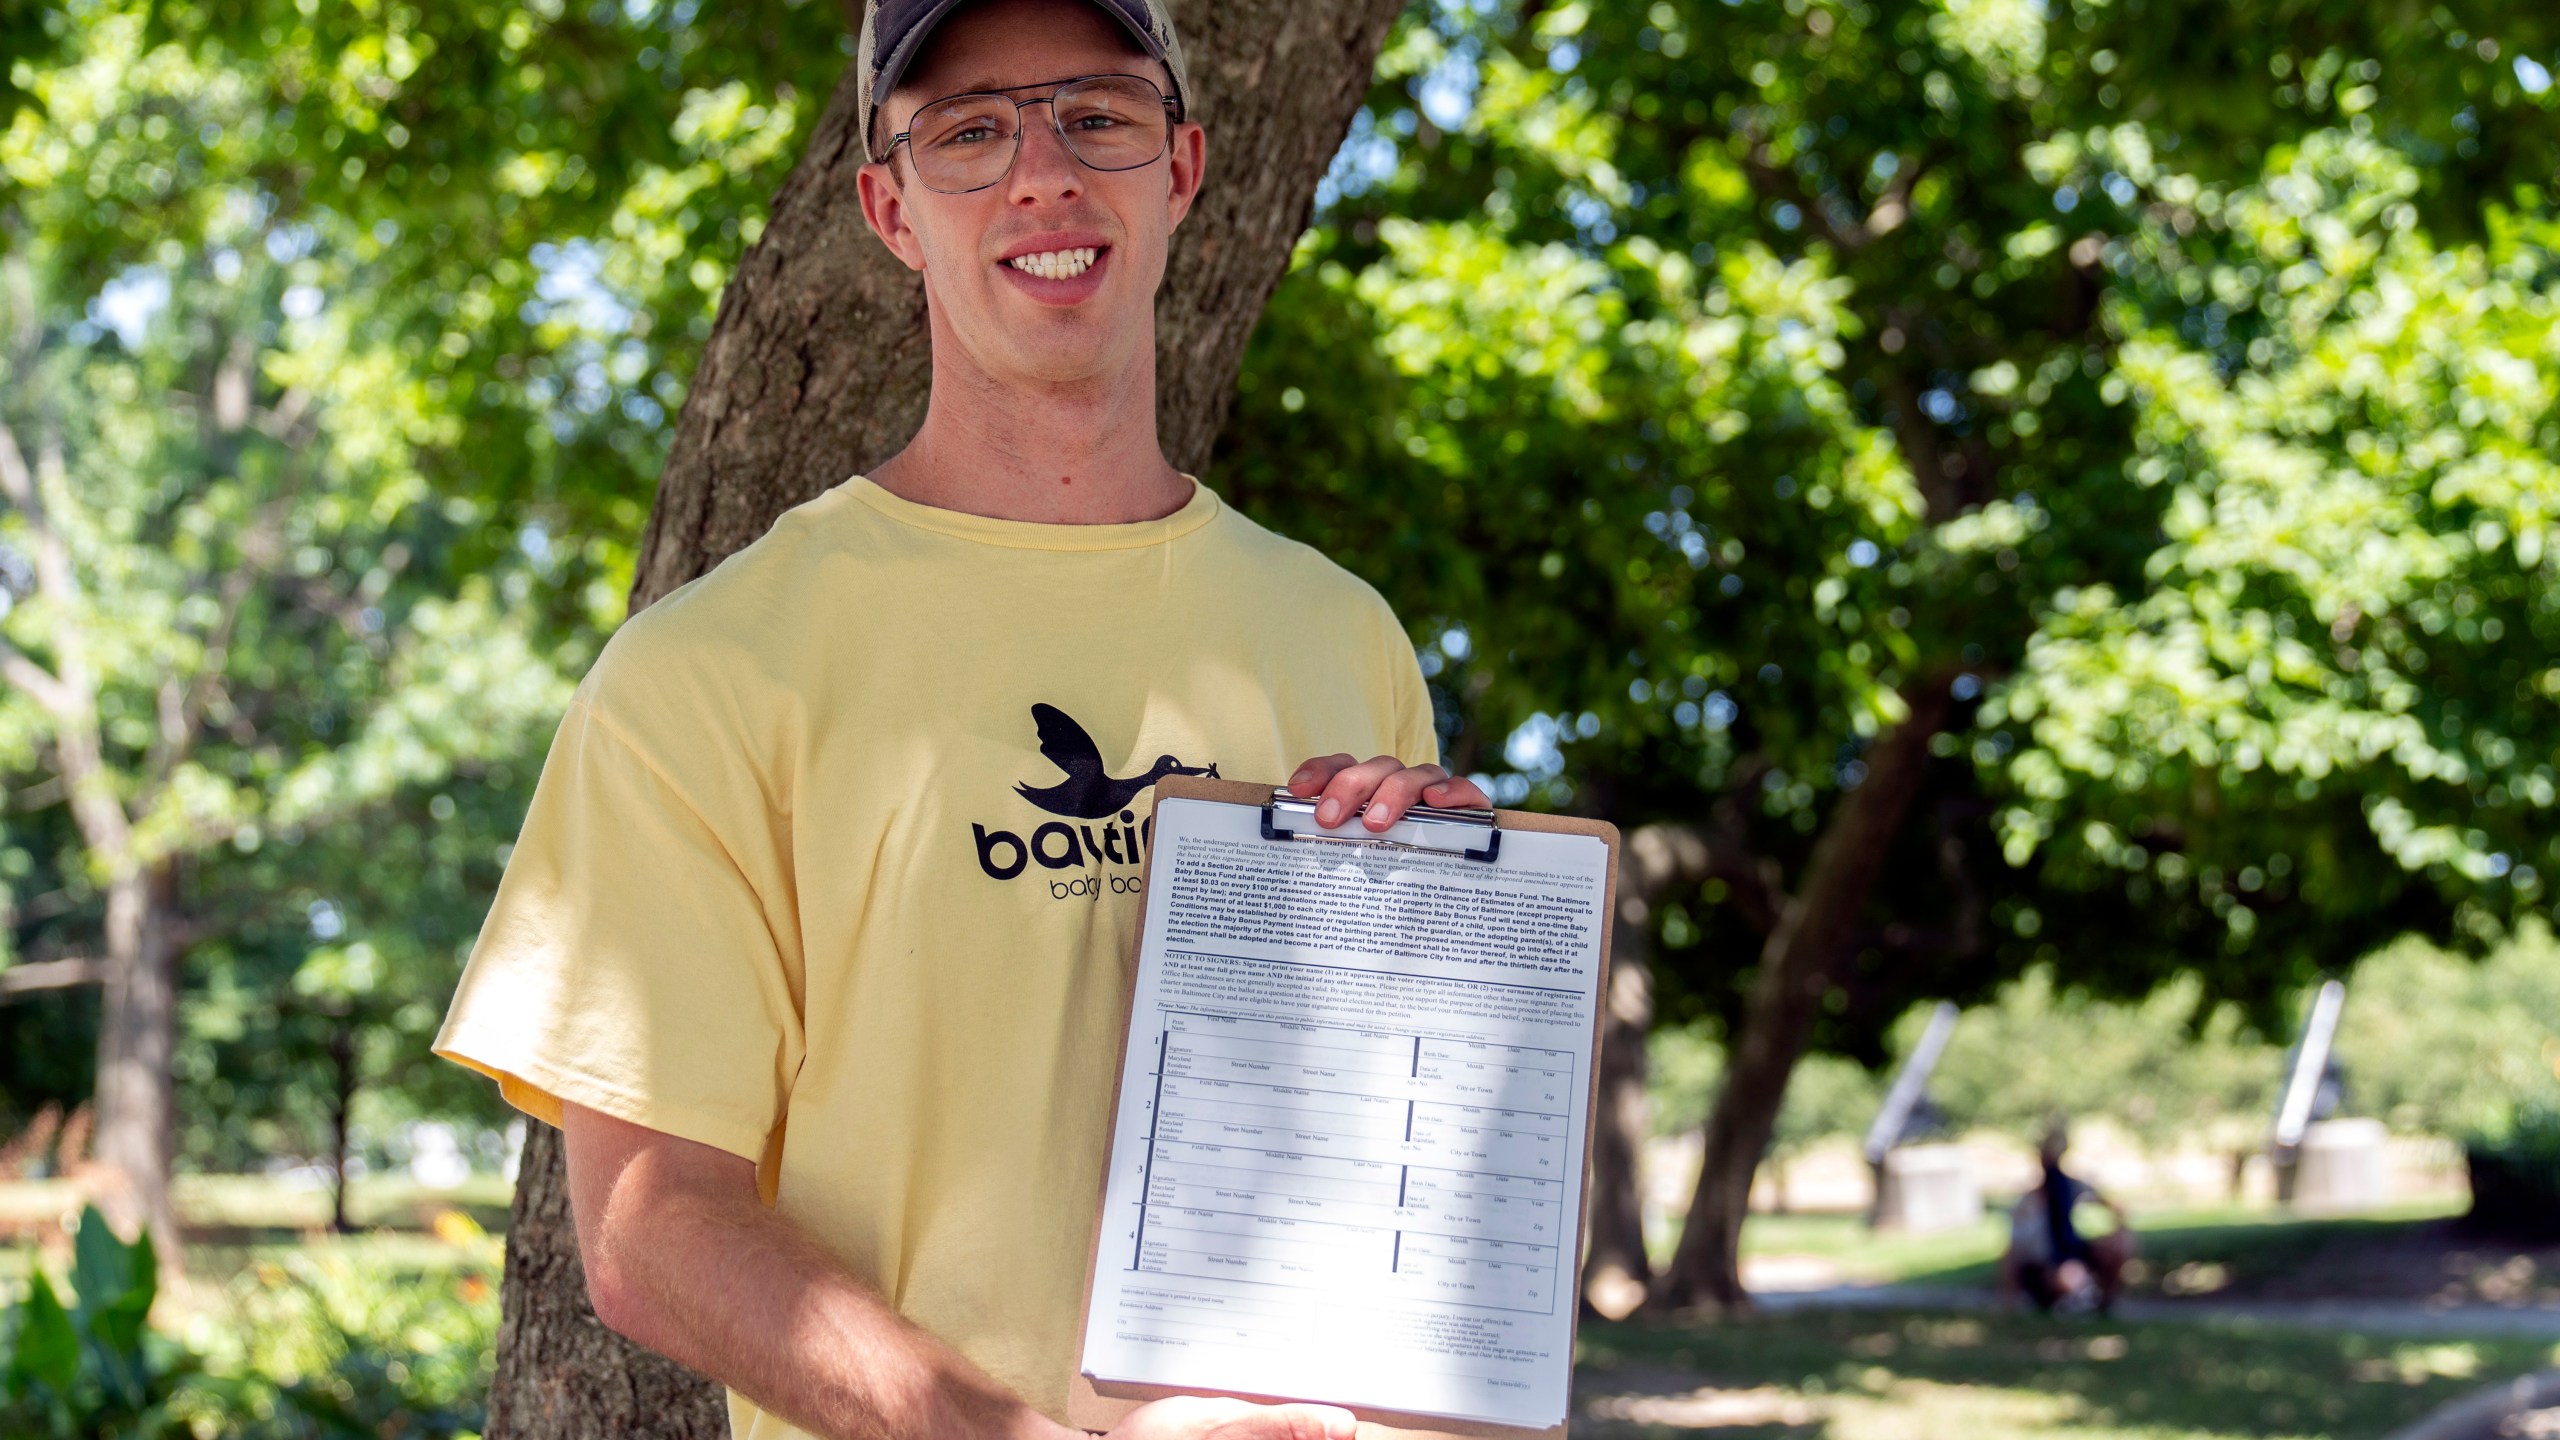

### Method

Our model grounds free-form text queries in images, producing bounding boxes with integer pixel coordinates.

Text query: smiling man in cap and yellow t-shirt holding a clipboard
[438,0,1485,1440]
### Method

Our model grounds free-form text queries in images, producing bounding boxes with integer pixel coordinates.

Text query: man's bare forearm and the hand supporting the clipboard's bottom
[561,1104,1352,1440]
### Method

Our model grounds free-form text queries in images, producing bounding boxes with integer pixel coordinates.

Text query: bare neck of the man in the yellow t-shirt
[870,330,1190,525]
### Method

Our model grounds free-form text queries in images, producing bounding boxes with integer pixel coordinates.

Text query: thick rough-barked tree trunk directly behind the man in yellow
[489,0,1400,1440]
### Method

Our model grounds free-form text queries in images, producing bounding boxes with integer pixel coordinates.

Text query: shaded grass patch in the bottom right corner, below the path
[1574,1309,2560,1440]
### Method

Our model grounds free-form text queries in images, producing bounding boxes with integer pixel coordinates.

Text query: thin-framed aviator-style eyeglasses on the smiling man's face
[883,74,1180,195]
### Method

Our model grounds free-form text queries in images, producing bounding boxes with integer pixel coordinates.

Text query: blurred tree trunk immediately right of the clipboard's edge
[1582,825,1708,1320]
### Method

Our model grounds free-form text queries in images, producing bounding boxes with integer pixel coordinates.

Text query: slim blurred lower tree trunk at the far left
[95,861,182,1268]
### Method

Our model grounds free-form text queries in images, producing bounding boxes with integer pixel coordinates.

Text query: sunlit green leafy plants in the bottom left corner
[0,1207,499,1440]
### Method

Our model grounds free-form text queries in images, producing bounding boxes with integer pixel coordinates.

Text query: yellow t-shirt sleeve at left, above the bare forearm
[435,692,801,1161]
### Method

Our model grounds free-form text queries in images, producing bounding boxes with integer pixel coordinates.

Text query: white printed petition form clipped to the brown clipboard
[1083,799,1608,1430]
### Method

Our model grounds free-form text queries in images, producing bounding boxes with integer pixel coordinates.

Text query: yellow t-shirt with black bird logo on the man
[435,479,1436,1440]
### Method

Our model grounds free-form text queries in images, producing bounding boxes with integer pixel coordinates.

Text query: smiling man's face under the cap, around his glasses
[860,0,1203,384]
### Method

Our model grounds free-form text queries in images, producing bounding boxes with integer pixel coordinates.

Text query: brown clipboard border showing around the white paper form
[1068,776,1618,1440]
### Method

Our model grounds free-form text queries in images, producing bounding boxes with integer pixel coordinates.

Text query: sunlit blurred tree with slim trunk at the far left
[0,15,593,1245]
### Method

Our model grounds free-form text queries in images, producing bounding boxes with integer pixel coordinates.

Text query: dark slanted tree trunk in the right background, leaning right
[1654,676,1948,1309]
